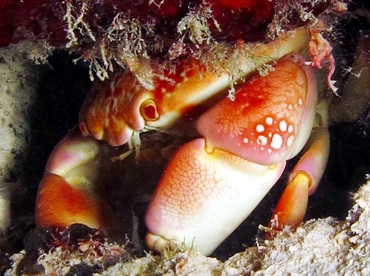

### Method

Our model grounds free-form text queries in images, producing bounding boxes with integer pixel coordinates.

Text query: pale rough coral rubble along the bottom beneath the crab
[5,181,370,276]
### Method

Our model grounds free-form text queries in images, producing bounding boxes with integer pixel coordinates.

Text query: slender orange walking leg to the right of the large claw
[269,101,330,230]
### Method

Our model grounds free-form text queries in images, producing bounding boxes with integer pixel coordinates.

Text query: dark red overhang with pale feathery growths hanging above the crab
[0,0,336,84]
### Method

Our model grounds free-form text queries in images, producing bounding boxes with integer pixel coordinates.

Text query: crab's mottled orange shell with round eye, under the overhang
[80,28,310,146]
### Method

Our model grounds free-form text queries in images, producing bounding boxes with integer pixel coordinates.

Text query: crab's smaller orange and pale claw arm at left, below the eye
[36,130,117,236]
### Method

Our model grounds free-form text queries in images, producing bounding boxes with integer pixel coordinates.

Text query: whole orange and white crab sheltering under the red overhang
[36,28,329,255]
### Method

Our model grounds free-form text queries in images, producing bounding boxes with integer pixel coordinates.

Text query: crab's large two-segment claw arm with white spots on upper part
[145,57,317,254]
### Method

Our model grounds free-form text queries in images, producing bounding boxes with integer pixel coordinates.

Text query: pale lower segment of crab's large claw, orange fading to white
[146,138,285,254]
